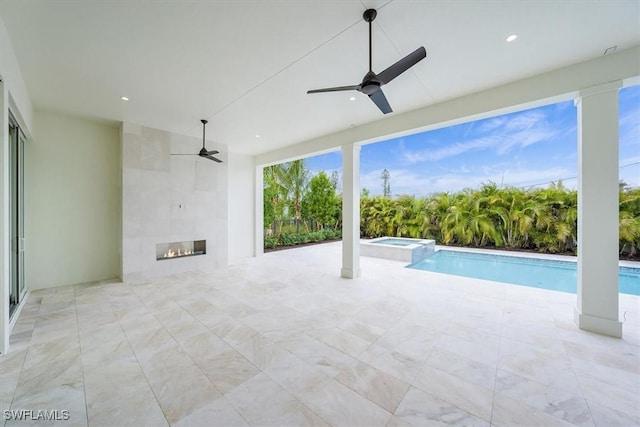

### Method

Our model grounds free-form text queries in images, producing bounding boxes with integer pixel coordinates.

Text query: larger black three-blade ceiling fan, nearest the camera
[307,9,427,114]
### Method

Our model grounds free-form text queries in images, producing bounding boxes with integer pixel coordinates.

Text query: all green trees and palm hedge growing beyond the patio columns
[264,160,640,260]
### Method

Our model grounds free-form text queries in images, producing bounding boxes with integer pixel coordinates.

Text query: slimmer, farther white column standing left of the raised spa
[340,144,360,279]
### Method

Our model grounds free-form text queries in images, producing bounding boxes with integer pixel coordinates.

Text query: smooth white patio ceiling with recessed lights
[0,0,640,154]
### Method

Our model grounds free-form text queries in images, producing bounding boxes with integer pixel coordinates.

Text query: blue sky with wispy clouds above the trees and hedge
[305,86,640,196]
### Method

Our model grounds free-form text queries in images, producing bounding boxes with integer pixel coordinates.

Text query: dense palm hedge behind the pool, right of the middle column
[360,183,640,259]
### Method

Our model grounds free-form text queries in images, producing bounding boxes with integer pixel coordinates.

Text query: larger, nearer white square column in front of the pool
[574,82,622,337]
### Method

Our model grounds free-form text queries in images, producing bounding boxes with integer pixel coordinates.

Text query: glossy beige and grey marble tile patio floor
[0,243,640,427]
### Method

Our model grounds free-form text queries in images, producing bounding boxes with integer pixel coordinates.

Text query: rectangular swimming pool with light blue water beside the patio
[407,250,640,295]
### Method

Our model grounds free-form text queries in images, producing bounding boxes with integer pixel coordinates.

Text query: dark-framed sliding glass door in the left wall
[9,114,25,317]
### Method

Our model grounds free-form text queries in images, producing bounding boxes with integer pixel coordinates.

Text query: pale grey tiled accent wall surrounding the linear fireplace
[121,123,228,281]
